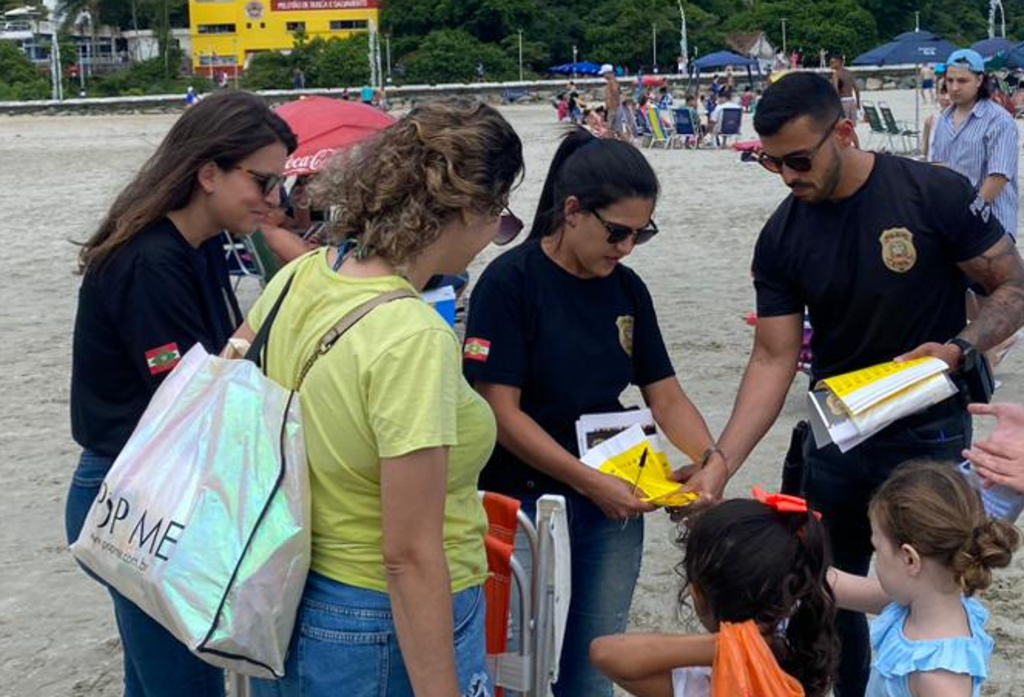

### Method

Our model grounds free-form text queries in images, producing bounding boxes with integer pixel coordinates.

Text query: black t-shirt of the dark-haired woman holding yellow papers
[463,241,675,495]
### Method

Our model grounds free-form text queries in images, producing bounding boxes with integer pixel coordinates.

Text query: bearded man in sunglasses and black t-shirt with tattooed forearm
[690,73,1024,697]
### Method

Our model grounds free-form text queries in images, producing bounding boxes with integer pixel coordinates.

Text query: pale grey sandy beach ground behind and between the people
[0,92,1024,697]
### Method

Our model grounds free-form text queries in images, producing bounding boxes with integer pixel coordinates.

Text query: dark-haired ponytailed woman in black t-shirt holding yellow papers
[464,128,720,697]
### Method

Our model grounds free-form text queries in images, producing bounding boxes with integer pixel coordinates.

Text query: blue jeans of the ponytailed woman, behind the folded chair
[512,493,643,697]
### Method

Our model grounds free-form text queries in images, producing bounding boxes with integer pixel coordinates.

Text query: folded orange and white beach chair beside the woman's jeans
[480,491,571,697]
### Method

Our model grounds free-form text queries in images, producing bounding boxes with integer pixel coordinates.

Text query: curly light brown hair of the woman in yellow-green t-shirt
[309,97,523,268]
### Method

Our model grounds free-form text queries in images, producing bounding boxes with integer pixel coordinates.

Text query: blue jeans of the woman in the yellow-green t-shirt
[250,572,493,697]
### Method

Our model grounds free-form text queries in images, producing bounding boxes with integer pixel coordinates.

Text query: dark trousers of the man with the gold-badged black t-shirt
[803,396,972,697]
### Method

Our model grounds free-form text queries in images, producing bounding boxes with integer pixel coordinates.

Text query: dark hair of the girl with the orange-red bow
[676,498,839,697]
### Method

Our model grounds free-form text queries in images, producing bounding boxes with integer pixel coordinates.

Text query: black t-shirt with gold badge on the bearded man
[754,155,1006,380]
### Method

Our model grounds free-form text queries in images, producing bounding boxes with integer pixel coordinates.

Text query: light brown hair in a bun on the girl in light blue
[869,461,1020,596]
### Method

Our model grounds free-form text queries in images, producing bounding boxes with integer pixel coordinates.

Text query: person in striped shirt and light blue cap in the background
[929,49,1019,239]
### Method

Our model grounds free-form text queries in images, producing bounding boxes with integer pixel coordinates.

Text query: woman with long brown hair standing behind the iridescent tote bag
[66,91,296,697]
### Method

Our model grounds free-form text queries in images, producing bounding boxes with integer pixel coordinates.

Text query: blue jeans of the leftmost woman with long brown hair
[65,450,224,697]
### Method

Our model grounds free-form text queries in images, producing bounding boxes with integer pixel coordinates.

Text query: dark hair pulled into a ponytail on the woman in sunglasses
[529,127,658,239]
